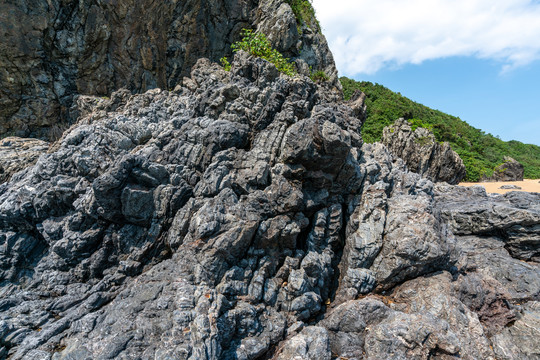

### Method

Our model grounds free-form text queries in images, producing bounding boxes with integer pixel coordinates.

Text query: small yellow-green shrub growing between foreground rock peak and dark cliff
[231,29,296,76]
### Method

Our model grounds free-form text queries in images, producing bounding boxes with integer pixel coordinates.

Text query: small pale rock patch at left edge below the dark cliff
[0,136,49,184]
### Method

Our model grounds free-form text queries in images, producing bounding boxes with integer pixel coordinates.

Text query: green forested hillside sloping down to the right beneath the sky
[340,77,540,181]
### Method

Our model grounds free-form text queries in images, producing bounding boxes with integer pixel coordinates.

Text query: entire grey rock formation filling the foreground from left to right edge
[0,53,540,360]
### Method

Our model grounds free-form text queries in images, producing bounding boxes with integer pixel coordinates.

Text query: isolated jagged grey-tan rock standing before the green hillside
[382,118,465,184]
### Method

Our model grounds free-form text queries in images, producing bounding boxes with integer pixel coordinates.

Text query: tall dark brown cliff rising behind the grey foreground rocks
[0,0,340,139]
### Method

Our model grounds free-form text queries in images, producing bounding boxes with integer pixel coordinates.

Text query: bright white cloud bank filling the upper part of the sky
[313,0,540,76]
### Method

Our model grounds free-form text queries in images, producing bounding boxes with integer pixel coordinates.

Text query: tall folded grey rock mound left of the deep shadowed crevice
[0,53,350,359]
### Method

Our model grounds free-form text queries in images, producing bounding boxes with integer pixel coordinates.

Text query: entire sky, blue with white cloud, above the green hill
[313,0,540,145]
